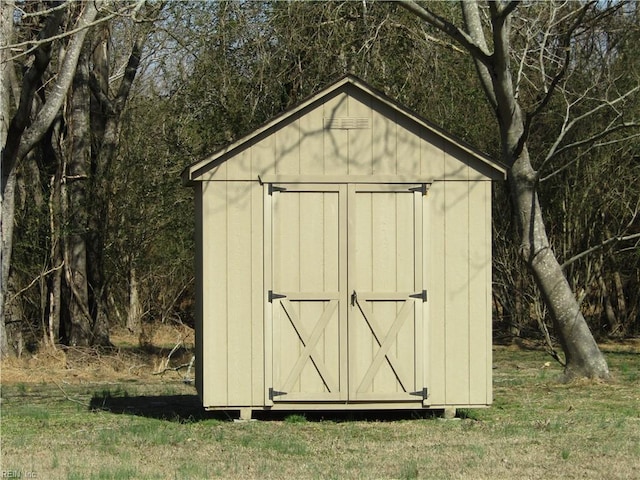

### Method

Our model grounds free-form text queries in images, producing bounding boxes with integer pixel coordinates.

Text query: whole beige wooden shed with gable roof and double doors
[183,76,505,418]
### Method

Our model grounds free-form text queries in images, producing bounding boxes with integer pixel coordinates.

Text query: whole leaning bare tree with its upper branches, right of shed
[400,0,622,378]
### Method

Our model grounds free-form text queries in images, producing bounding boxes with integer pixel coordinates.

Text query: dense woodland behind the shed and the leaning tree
[0,0,640,362]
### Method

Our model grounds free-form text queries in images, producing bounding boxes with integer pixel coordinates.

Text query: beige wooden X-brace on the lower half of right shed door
[352,294,414,393]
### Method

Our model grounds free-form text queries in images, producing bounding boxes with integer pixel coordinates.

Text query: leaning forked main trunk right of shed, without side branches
[472,2,610,380]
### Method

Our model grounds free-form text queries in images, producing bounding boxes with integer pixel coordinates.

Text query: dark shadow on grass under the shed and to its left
[89,392,450,423]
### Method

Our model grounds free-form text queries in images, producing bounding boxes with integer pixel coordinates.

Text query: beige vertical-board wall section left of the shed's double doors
[196,182,264,406]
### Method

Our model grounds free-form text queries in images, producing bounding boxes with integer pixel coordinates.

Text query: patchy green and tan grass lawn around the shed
[1,336,640,480]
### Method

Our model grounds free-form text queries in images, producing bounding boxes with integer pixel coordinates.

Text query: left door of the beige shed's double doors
[267,184,347,402]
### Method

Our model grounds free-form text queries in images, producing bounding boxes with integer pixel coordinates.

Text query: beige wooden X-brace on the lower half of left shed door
[280,298,338,392]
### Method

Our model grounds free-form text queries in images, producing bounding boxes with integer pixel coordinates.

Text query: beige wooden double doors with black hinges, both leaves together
[265,184,426,403]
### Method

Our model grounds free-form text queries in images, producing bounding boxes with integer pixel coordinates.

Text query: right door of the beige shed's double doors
[348,185,426,401]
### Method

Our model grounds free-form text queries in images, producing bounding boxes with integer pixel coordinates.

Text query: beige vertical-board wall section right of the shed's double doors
[425,182,492,406]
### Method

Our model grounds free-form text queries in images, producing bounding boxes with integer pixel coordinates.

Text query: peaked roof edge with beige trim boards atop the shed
[181,74,507,185]
